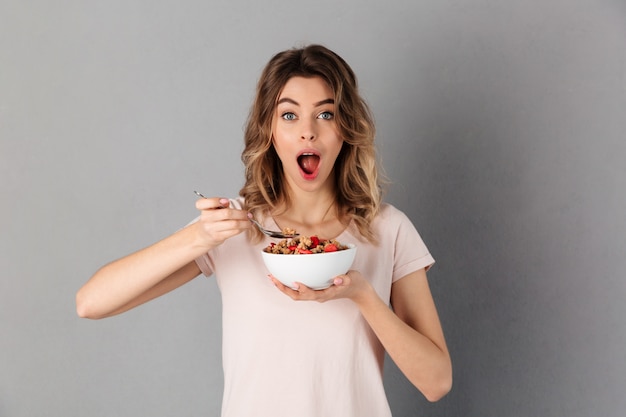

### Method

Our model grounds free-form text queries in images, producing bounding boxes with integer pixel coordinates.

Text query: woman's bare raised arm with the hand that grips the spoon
[76,198,250,318]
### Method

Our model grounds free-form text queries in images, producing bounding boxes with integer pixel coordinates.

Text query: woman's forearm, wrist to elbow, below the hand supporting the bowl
[355,287,452,401]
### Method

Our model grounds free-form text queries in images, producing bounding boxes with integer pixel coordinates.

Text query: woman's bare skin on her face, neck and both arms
[76,77,452,401]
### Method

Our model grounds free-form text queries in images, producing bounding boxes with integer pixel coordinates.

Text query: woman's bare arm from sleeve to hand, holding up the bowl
[272,269,452,401]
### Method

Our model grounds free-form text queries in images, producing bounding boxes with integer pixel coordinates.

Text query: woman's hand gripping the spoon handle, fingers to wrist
[196,197,252,249]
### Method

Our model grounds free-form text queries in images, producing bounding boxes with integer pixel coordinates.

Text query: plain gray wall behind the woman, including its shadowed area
[0,0,626,417]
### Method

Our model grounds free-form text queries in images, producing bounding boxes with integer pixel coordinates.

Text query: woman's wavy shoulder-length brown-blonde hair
[239,45,382,243]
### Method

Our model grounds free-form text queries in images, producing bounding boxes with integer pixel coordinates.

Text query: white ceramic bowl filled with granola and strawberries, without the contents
[261,244,356,290]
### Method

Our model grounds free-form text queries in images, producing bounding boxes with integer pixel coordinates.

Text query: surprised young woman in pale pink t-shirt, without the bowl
[77,45,452,417]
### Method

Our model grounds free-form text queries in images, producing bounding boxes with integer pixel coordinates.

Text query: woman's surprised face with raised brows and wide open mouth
[272,77,343,191]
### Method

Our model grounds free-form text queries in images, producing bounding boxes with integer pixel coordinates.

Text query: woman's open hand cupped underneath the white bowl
[270,270,371,303]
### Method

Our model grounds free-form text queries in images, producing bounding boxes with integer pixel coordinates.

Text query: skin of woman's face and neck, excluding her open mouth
[272,77,347,236]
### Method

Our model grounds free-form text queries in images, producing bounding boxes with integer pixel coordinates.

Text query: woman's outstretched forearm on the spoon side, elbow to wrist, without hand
[76,226,207,318]
